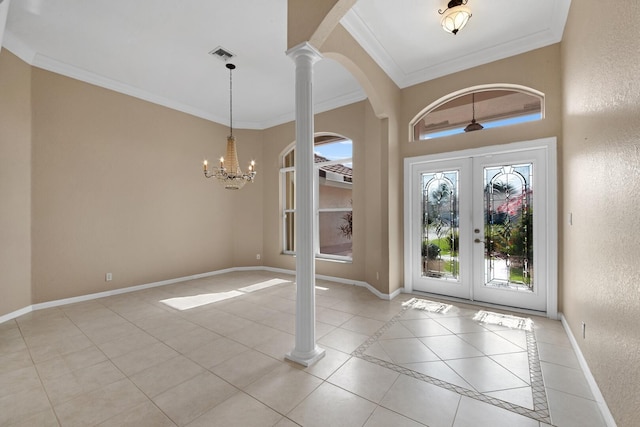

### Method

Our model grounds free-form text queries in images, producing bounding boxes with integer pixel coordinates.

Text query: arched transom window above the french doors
[412,87,544,141]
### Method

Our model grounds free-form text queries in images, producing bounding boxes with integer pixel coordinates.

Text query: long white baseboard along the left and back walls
[0,266,401,324]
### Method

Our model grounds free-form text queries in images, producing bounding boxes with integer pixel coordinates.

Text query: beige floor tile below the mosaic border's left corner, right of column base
[327,357,399,403]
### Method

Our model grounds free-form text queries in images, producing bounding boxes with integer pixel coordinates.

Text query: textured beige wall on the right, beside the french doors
[562,1,640,426]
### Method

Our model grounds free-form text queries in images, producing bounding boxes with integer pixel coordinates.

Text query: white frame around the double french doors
[403,137,558,319]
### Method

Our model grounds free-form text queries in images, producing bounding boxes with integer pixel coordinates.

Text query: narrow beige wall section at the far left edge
[0,51,31,317]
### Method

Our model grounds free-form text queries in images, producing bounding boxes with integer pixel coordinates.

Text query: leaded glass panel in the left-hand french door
[421,170,460,282]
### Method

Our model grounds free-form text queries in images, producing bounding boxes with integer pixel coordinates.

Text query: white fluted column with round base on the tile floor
[285,42,324,366]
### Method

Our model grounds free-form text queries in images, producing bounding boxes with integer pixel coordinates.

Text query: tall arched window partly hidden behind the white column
[280,135,353,260]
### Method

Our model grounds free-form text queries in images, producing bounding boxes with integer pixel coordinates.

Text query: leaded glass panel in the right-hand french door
[484,163,534,291]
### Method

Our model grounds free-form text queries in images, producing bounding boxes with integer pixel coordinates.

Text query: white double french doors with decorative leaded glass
[405,143,556,312]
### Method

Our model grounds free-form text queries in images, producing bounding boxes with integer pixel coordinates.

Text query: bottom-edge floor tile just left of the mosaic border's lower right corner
[453,397,538,427]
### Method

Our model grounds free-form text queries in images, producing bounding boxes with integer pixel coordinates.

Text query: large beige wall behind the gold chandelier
[32,68,262,303]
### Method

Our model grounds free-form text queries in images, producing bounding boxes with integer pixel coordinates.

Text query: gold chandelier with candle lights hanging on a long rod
[204,64,256,190]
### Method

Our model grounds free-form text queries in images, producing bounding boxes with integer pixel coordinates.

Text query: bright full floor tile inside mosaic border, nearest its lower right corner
[446,356,528,393]
